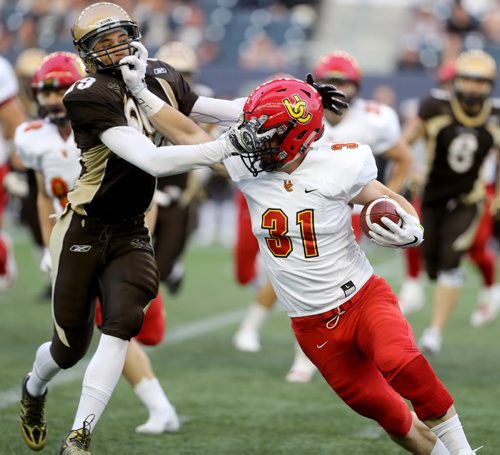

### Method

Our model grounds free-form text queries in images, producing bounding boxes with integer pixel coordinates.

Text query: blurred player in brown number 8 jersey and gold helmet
[404,50,500,354]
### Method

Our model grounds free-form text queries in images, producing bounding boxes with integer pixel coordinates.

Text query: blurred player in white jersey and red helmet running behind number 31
[234,51,411,382]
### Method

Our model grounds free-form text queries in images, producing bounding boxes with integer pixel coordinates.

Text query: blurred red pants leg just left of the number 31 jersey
[234,191,259,284]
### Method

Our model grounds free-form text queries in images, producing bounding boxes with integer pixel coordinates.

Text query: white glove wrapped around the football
[369,207,424,248]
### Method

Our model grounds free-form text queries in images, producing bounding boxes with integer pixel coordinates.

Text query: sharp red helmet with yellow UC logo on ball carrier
[242,78,324,176]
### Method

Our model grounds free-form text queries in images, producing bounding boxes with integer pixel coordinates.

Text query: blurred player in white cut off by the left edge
[0,56,26,291]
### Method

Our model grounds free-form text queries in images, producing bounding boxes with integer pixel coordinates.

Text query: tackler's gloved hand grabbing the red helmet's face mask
[226,114,276,154]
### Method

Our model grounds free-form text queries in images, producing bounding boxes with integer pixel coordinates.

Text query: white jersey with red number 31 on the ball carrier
[224,144,377,317]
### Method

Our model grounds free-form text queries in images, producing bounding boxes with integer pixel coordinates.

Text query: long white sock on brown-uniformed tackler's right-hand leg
[71,334,128,431]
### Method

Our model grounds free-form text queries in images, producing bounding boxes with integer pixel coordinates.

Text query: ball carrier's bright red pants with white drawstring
[292,276,453,437]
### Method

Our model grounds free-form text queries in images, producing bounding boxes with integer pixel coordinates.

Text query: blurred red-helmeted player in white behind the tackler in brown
[15,52,179,440]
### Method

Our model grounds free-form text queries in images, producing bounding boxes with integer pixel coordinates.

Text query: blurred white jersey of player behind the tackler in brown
[14,119,82,214]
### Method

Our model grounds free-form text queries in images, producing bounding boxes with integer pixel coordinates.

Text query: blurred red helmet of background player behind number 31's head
[314,51,361,88]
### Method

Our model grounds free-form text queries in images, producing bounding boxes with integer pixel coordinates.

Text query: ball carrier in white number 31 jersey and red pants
[118,66,474,455]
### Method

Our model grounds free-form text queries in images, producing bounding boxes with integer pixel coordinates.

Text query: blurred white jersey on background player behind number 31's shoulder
[318,98,401,155]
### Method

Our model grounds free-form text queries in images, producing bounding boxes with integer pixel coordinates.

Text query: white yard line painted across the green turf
[0,310,245,409]
